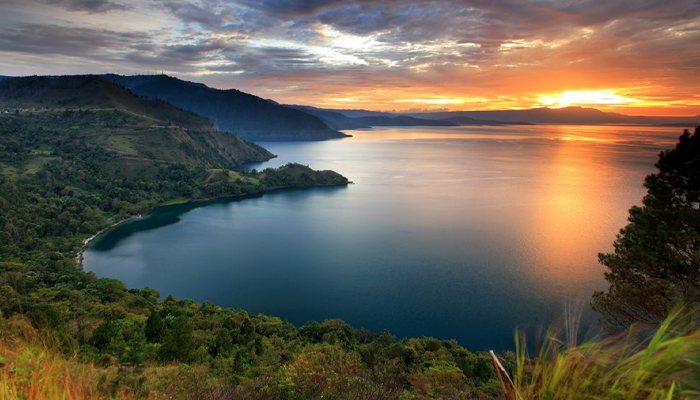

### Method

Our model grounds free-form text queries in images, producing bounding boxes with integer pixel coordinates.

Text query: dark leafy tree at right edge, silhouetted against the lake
[592,127,700,332]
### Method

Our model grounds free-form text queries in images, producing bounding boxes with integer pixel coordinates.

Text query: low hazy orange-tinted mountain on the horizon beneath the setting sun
[406,107,656,124]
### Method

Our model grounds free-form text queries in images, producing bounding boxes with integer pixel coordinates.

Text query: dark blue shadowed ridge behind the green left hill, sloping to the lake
[106,74,348,141]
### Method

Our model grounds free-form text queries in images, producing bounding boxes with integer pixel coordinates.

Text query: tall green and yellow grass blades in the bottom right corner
[492,311,700,400]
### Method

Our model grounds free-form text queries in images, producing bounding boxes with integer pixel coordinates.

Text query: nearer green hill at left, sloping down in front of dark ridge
[0,75,274,169]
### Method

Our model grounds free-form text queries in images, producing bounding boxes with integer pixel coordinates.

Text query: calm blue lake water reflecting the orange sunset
[85,126,682,350]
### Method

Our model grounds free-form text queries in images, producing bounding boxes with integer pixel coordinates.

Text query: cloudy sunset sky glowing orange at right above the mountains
[0,0,700,116]
